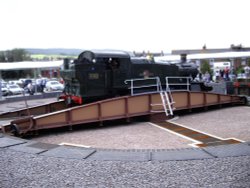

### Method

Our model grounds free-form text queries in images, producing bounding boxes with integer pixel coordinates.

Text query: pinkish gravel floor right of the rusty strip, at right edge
[174,106,250,141]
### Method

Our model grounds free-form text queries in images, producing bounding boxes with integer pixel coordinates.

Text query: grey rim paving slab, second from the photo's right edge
[152,149,213,161]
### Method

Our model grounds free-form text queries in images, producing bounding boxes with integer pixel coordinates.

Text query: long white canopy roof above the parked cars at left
[0,60,63,71]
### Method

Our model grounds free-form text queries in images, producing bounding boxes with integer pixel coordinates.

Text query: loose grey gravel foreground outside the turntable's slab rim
[0,149,250,188]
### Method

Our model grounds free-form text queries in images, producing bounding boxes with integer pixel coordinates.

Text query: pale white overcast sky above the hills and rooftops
[0,0,250,52]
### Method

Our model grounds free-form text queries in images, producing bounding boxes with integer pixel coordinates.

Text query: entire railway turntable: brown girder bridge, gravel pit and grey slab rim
[0,83,250,166]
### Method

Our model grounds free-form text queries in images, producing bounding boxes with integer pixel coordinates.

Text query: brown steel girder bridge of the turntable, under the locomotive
[1,81,245,146]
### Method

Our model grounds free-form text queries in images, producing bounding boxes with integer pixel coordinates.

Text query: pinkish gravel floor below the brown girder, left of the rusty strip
[32,123,192,149]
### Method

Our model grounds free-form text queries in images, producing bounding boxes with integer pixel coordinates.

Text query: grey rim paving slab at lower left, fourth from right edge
[41,146,95,159]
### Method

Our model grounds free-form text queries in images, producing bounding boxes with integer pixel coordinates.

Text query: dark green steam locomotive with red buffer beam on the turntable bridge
[60,51,203,104]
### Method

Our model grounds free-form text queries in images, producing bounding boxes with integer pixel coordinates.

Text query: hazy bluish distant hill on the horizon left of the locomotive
[25,48,83,56]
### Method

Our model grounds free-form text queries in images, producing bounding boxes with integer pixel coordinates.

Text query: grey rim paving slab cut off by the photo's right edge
[203,144,250,157]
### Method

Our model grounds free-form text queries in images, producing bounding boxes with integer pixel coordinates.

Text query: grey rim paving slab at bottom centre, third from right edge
[88,150,151,161]
